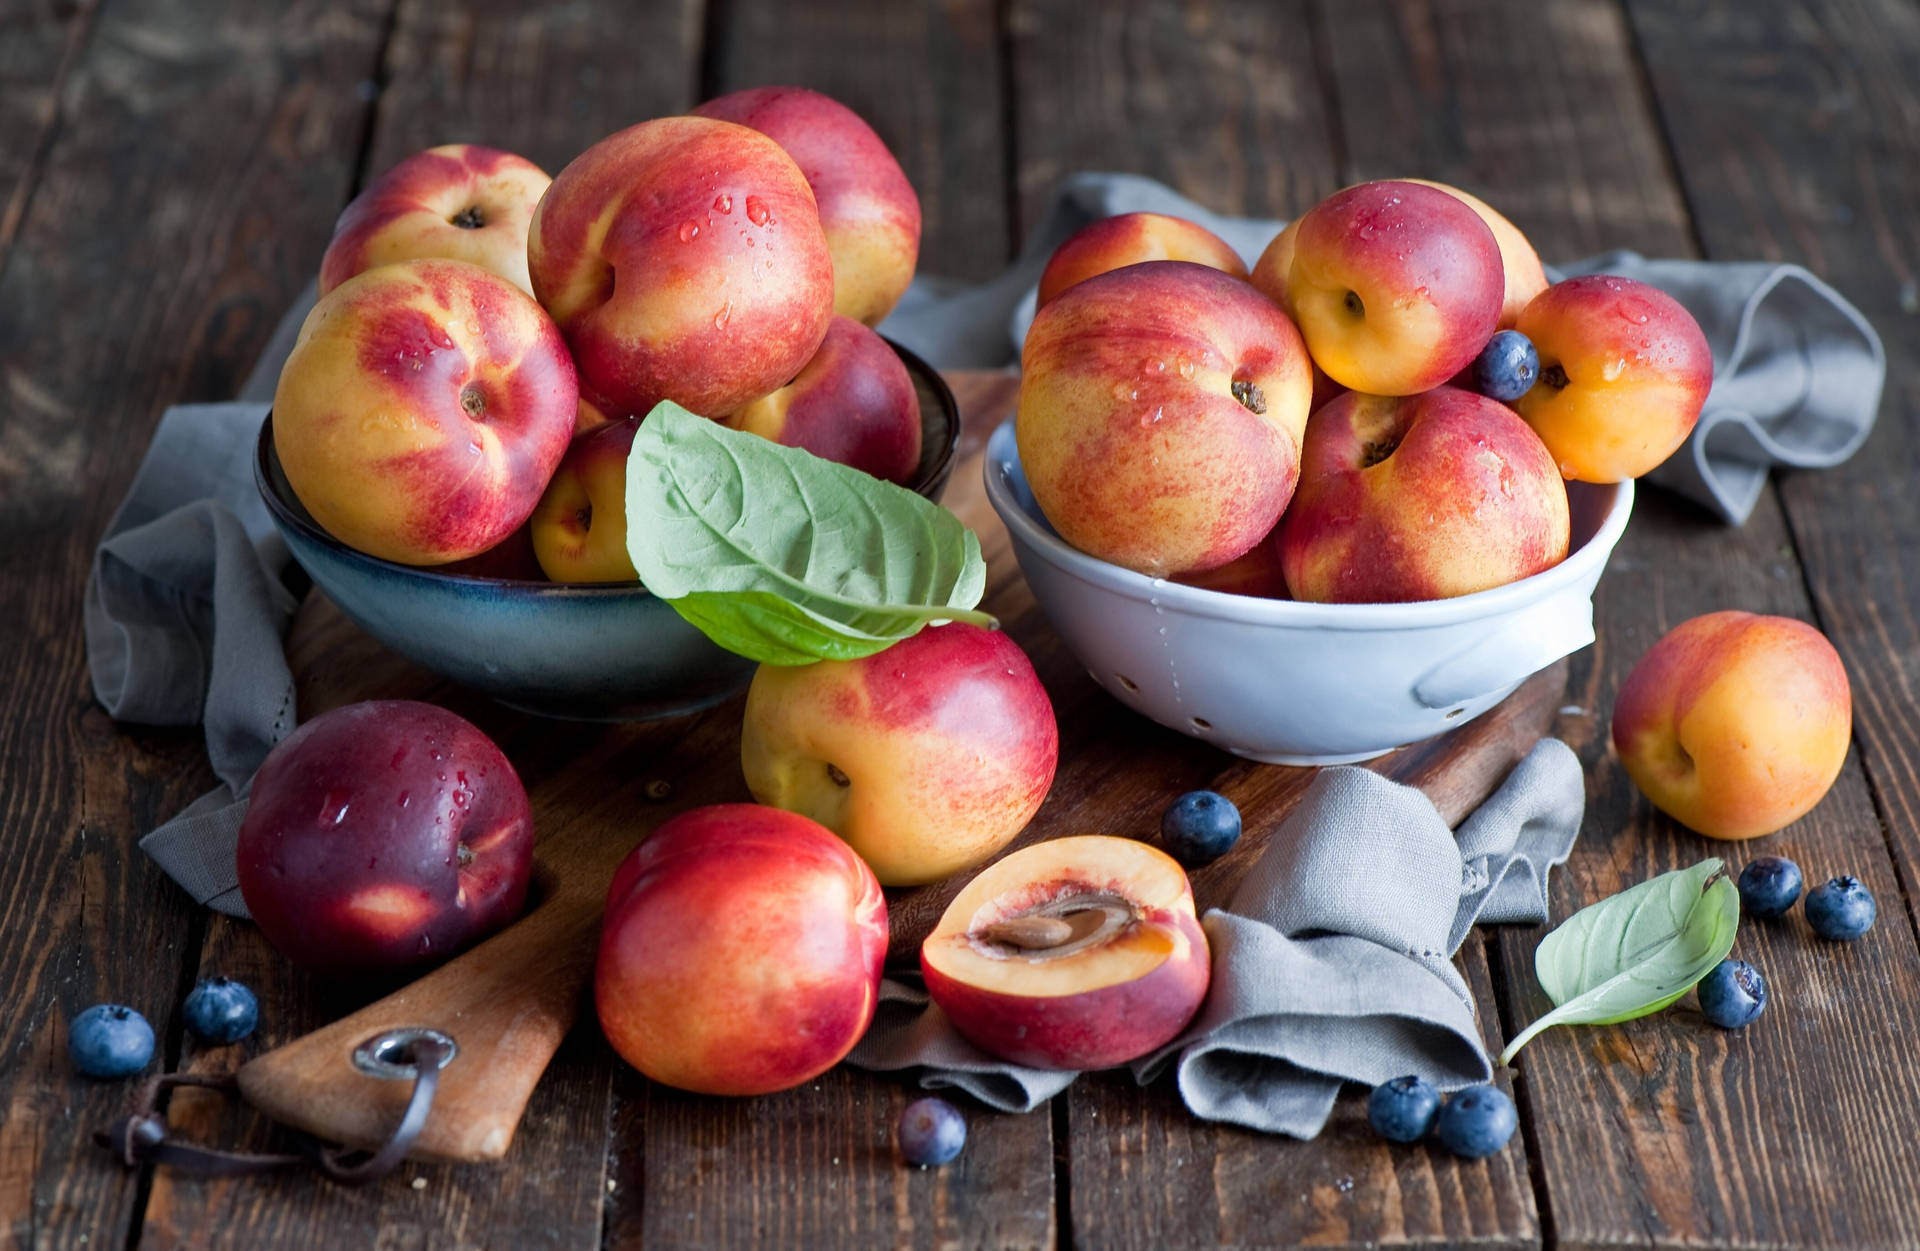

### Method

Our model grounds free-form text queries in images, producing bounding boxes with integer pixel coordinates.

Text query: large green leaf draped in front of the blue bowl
[626,401,995,664]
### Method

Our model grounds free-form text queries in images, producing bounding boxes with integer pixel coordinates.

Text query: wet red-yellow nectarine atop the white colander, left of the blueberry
[1269,180,1505,395]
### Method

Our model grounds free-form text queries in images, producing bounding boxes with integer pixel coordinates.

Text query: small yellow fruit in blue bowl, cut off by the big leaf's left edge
[528,416,639,581]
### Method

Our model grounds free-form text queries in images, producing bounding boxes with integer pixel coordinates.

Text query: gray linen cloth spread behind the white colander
[881,173,1887,526]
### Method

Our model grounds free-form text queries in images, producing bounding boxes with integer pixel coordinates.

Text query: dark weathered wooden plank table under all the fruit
[0,0,1920,1249]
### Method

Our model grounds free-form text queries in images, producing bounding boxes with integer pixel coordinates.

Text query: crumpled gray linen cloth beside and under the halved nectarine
[849,739,1586,1138]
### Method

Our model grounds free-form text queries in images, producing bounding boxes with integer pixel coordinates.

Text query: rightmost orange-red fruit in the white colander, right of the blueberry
[1513,274,1713,482]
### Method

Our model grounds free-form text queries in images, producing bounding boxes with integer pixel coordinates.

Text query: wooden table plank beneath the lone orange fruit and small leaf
[1329,0,1920,1247]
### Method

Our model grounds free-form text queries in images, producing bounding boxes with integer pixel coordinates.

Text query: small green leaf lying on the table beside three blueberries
[1500,860,1740,1065]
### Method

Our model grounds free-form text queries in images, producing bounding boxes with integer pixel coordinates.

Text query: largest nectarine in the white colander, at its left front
[1014,261,1313,578]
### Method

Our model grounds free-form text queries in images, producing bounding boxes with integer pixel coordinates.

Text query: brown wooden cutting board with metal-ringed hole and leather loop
[240,372,1567,1161]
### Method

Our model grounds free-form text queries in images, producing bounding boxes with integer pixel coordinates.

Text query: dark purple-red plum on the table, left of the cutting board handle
[238,700,534,975]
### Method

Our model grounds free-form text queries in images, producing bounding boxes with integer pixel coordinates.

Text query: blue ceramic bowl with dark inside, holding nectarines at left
[253,345,960,721]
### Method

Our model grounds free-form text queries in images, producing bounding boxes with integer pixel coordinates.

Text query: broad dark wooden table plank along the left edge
[0,0,380,1247]
